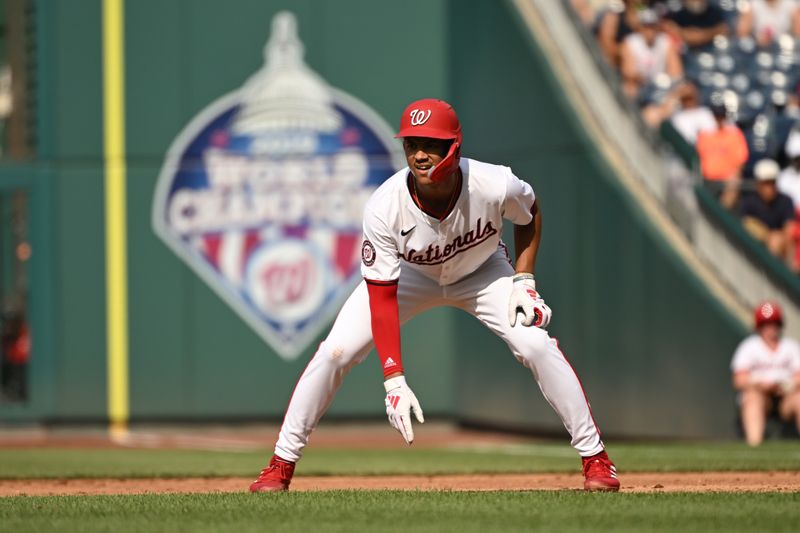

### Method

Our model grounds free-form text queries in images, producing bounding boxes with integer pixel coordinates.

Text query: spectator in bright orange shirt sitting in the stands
[695,104,749,209]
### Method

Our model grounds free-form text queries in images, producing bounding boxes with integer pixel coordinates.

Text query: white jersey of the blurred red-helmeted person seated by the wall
[731,334,800,383]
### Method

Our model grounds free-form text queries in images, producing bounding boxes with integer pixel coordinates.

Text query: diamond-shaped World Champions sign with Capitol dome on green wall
[153,12,404,360]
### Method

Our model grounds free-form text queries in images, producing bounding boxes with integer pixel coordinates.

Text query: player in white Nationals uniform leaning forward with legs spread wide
[250,99,619,492]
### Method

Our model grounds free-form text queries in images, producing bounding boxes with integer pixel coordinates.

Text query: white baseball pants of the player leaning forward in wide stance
[275,249,603,461]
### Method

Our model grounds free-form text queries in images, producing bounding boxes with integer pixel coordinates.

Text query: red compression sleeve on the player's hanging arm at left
[367,280,403,377]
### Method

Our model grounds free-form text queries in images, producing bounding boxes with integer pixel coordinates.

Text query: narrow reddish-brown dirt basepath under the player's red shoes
[0,472,800,496]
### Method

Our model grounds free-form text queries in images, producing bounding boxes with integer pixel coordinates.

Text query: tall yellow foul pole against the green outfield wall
[103,0,129,438]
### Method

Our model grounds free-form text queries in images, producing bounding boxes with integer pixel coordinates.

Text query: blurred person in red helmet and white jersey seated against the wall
[731,302,800,446]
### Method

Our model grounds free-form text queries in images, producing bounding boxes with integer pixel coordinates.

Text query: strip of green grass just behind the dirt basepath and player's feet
[0,441,800,479]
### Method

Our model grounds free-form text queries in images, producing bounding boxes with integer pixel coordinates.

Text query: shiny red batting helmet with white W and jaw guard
[395,98,462,181]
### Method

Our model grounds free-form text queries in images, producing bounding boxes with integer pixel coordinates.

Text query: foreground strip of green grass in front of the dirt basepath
[0,491,800,533]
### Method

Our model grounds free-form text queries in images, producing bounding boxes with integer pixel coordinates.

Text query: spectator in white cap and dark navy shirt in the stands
[739,159,795,261]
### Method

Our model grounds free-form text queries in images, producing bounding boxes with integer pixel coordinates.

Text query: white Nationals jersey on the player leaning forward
[361,157,536,285]
